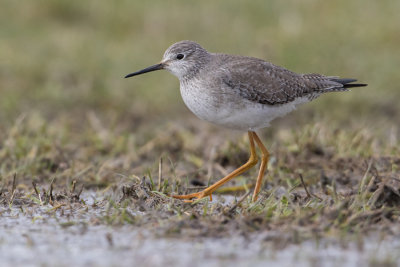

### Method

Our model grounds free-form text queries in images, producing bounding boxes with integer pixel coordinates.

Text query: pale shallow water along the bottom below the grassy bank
[0,193,400,267]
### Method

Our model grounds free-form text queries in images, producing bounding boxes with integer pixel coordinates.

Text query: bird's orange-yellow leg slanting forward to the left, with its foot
[172,131,258,202]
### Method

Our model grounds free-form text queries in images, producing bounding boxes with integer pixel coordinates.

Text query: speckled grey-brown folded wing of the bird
[223,57,346,105]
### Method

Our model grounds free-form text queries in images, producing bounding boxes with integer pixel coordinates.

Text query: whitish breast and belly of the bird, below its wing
[180,81,309,131]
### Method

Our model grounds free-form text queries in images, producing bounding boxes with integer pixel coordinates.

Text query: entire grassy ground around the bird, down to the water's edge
[0,0,400,248]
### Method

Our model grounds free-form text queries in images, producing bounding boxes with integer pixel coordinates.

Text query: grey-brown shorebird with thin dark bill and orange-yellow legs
[125,41,366,202]
